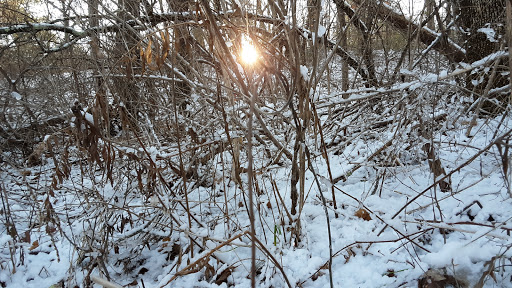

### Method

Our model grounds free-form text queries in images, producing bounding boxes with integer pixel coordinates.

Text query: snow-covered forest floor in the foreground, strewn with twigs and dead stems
[0,104,512,288]
